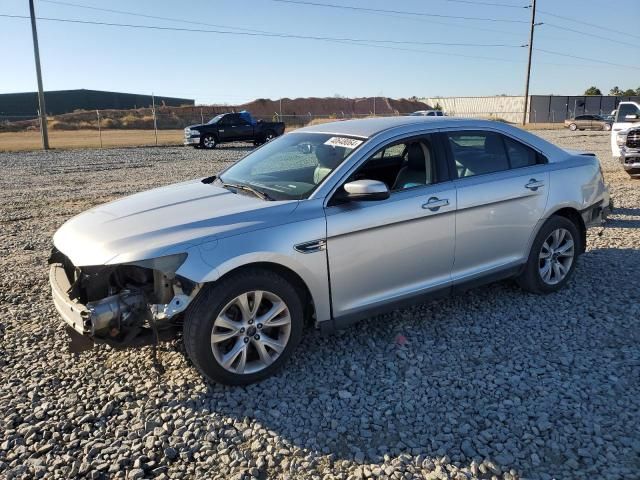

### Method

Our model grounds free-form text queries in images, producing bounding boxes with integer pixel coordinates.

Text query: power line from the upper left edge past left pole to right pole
[0,14,524,48]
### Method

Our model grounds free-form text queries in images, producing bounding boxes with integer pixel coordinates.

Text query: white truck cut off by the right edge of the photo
[611,102,640,177]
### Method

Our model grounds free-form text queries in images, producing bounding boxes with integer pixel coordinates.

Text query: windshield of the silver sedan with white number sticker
[219,133,364,200]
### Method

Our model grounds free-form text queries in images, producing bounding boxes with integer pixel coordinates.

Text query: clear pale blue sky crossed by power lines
[0,0,640,104]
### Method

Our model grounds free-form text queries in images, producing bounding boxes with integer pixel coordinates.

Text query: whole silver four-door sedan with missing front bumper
[50,117,610,385]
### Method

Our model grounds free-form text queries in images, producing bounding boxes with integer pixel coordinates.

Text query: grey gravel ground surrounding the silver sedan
[0,131,640,479]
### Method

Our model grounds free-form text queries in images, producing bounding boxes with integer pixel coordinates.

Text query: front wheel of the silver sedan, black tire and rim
[184,269,304,385]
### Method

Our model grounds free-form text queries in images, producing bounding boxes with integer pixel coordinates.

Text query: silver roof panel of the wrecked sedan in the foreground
[292,116,496,138]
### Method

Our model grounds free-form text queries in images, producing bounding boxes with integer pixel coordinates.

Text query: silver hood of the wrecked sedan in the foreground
[53,180,297,266]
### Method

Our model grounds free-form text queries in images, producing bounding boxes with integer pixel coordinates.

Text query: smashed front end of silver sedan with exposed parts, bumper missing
[49,249,200,352]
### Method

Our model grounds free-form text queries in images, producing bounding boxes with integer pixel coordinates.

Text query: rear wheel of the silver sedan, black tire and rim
[517,216,582,294]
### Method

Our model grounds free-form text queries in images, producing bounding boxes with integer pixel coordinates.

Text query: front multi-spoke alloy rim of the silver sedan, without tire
[211,290,291,374]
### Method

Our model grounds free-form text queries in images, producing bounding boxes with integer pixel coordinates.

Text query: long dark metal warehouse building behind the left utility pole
[0,89,195,117]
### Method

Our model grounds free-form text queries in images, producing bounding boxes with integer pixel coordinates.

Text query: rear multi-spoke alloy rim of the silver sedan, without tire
[538,228,575,285]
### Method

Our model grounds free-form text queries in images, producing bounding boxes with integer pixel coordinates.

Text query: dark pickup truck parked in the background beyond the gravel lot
[184,112,284,148]
